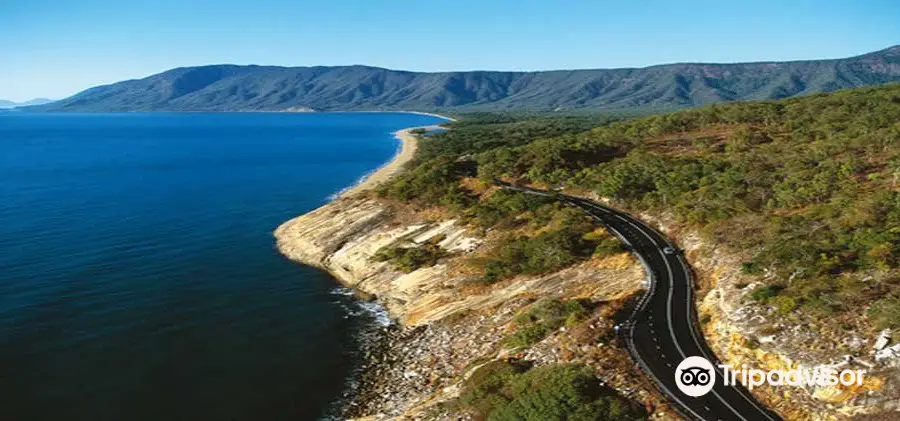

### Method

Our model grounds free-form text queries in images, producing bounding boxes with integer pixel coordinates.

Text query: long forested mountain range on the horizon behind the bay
[31,45,900,111]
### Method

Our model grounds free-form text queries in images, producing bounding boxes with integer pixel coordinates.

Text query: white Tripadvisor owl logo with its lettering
[675,357,865,397]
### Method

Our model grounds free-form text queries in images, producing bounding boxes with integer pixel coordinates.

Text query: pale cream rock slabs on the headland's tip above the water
[275,198,485,326]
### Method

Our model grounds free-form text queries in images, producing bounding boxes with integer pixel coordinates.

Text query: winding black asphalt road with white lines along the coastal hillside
[504,185,781,421]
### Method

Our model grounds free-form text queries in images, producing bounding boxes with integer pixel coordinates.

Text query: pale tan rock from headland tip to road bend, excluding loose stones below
[275,197,643,326]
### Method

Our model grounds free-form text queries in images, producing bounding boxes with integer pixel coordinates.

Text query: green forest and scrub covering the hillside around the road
[379,84,900,327]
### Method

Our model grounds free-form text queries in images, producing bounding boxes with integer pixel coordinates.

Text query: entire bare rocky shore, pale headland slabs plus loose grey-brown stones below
[275,197,674,419]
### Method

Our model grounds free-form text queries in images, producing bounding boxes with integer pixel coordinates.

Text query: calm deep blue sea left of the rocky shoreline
[0,113,440,421]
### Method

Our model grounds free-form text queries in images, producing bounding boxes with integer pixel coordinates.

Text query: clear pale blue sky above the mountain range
[0,0,900,100]
